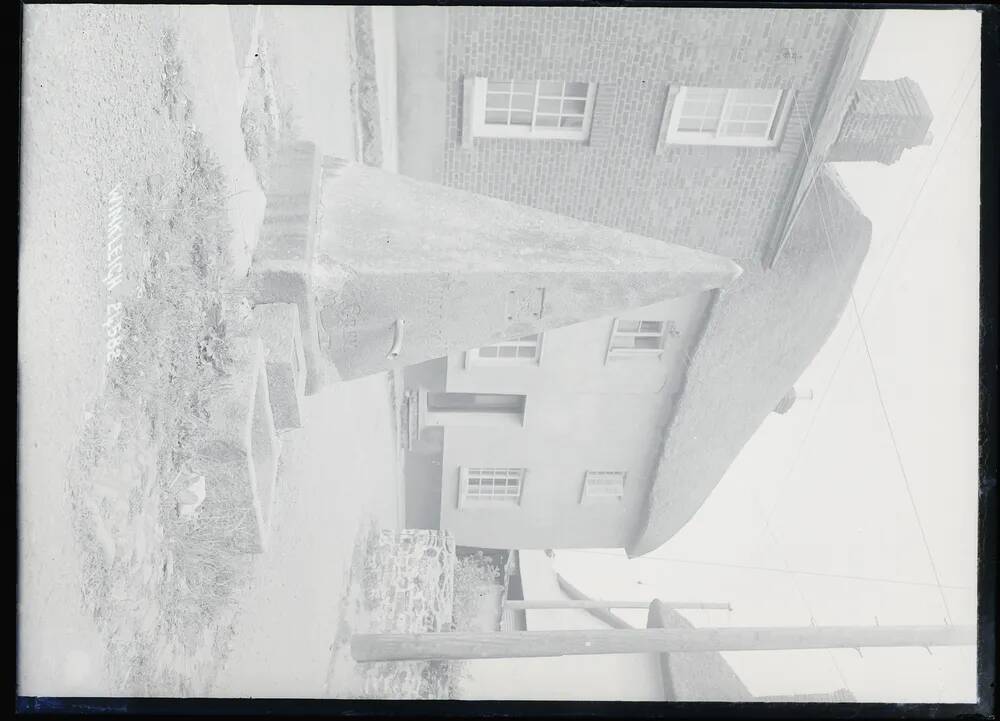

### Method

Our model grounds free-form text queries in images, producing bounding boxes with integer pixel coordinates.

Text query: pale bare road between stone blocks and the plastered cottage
[211,374,399,698]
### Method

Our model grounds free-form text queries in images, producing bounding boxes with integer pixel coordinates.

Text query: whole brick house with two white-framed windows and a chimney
[396,7,930,265]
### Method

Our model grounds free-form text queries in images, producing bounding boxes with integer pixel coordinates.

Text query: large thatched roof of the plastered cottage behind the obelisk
[626,166,871,556]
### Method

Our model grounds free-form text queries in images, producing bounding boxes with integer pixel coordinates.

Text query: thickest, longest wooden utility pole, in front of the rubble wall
[351,626,976,661]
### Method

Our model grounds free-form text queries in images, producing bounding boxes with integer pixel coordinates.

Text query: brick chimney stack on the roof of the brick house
[827,78,934,165]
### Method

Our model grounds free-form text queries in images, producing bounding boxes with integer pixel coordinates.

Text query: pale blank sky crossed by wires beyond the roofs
[556,10,980,703]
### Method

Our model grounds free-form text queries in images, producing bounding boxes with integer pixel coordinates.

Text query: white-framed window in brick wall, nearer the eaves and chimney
[666,87,791,147]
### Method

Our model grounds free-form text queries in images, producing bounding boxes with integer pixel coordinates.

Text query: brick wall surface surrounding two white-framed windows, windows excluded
[442,6,846,259]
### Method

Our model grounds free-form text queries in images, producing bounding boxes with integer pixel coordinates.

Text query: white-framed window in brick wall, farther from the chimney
[470,78,597,140]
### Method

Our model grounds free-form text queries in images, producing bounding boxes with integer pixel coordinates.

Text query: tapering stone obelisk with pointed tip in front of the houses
[253,144,740,390]
